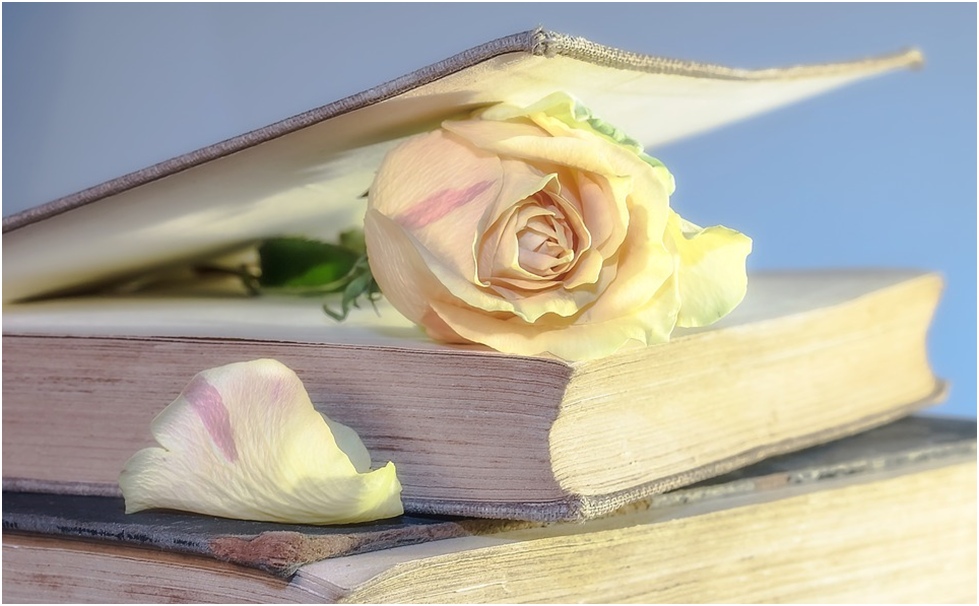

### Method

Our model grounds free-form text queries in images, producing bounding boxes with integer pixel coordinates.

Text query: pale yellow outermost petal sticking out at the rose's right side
[667,211,751,327]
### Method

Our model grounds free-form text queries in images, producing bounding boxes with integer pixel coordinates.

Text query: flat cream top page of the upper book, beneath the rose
[3,269,937,355]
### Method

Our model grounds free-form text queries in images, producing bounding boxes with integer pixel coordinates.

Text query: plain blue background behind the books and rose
[3,3,976,416]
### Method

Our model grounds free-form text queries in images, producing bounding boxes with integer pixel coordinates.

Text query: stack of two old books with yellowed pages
[2,30,976,603]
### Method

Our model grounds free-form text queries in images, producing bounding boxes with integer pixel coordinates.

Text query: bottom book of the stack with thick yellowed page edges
[3,418,977,603]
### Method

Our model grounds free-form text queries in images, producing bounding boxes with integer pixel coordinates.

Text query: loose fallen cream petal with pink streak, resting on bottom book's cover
[119,360,402,524]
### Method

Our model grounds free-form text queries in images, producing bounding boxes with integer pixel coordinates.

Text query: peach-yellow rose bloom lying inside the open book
[364,93,751,360]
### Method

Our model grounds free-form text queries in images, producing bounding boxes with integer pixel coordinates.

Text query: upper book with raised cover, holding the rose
[3,29,941,520]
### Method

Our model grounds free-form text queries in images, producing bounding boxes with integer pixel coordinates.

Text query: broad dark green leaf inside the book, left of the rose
[258,237,361,293]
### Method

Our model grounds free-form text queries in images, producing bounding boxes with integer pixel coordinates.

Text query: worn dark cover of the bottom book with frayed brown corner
[3,417,976,576]
